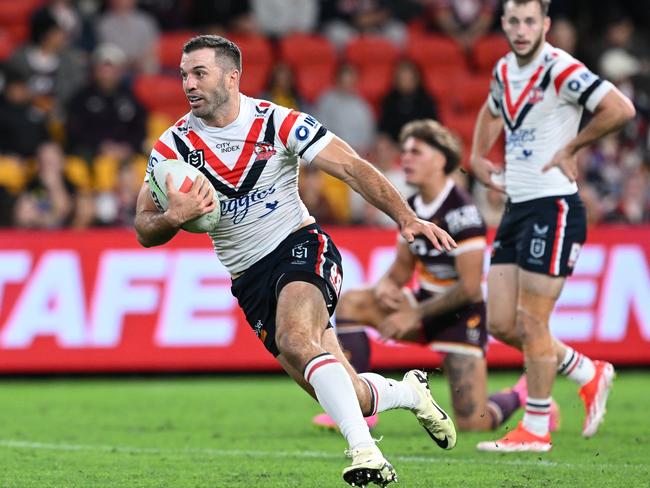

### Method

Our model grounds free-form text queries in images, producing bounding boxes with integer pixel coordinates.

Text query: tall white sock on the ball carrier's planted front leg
[303,353,375,449]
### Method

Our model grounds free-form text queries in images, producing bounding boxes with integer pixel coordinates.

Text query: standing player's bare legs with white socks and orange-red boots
[478,264,613,451]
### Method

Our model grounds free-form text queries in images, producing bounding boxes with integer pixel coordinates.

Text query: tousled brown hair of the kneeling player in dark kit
[399,119,462,175]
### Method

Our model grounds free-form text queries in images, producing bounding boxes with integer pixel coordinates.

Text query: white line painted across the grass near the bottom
[0,439,647,469]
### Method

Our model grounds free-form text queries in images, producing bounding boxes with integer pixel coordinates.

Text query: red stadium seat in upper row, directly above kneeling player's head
[406,35,467,76]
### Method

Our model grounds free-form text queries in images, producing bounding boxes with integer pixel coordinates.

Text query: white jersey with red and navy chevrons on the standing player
[488,43,612,203]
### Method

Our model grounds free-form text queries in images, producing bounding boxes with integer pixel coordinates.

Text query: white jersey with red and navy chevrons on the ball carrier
[145,94,334,274]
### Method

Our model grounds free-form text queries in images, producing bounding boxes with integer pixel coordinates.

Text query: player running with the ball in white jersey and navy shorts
[135,36,456,486]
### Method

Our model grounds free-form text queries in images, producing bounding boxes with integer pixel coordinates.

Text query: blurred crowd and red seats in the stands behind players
[0,0,650,229]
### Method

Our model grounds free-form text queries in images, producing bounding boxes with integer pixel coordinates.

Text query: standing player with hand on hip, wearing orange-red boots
[471,0,635,452]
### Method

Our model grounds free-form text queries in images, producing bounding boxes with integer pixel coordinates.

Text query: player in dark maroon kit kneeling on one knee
[314,119,556,430]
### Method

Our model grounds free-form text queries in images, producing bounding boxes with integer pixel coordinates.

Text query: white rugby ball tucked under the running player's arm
[149,159,221,234]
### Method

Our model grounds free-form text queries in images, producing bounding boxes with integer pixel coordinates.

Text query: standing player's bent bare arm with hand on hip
[542,81,636,181]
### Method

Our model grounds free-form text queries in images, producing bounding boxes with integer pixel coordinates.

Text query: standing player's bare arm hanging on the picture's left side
[470,101,505,191]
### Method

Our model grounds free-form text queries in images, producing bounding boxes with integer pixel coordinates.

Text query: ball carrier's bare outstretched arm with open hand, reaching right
[312,137,456,251]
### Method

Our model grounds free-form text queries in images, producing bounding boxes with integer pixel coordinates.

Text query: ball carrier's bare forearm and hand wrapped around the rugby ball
[135,175,216,247]
